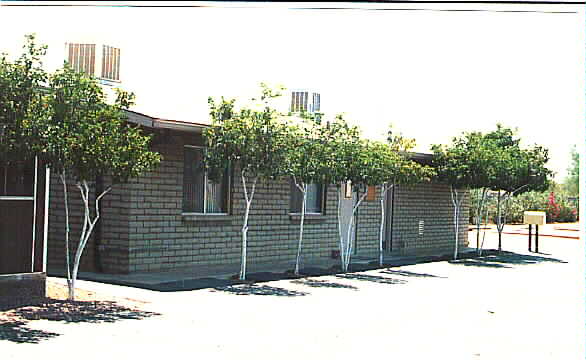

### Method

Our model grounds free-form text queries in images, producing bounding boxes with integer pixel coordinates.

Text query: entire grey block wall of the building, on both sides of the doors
[48,128,468,273]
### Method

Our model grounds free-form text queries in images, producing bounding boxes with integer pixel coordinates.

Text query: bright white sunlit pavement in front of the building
[0,227,586,360]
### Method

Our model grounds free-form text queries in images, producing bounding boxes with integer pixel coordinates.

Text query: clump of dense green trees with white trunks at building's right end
[432,124,551,259]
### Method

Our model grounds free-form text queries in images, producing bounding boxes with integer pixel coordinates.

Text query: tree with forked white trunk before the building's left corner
[36,65,160,300]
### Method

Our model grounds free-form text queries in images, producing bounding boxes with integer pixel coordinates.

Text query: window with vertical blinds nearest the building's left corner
[183,146,230,214]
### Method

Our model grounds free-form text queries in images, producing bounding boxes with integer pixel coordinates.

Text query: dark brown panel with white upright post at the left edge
[0,160,47,274]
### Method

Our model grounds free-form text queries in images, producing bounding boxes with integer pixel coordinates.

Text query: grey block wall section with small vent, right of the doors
[392,184,470,255]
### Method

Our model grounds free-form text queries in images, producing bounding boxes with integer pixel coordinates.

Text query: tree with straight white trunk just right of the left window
[204,84,291,280]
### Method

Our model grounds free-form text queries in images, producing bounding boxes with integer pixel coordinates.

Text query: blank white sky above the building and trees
[0,1,586,181]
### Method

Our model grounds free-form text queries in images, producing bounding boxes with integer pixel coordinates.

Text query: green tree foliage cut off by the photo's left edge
[0,35,47,165]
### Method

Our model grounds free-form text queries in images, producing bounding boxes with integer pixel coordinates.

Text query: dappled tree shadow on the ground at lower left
[0,300,160,344]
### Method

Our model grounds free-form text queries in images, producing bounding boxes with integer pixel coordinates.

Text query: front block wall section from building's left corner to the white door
[129,136,338,272]
